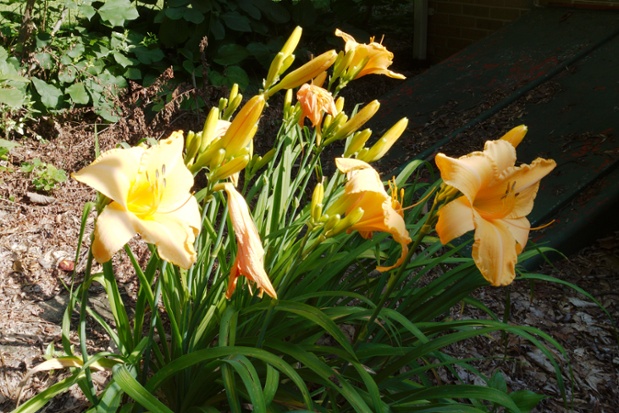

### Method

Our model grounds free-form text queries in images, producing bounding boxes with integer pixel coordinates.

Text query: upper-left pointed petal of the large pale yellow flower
[71,147,145,208]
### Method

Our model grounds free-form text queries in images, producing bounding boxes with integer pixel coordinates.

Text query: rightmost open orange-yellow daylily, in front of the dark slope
[435,127,556,286]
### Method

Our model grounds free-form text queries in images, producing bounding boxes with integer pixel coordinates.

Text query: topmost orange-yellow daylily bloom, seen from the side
[335,29,406,79]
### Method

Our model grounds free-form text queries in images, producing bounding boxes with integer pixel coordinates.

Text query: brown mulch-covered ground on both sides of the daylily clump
[0,42,619,413]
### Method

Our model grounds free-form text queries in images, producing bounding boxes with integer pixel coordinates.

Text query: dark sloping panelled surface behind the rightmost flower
[372,8,619,262]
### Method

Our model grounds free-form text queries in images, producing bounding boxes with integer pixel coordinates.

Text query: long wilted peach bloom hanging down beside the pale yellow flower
[223,182,277,299]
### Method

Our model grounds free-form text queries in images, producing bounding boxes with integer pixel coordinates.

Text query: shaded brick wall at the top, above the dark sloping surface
[428,0,536,63]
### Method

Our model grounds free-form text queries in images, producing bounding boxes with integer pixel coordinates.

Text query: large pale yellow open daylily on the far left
[72,131,202,268]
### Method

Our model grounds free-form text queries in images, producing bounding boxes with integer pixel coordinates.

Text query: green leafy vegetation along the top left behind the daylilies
[0,0,410,130]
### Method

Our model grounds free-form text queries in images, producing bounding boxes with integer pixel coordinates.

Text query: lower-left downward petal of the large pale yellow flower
[92,202,138,264]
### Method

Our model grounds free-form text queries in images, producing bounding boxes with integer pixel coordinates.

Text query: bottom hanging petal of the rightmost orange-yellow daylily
[473,213,519,287]
